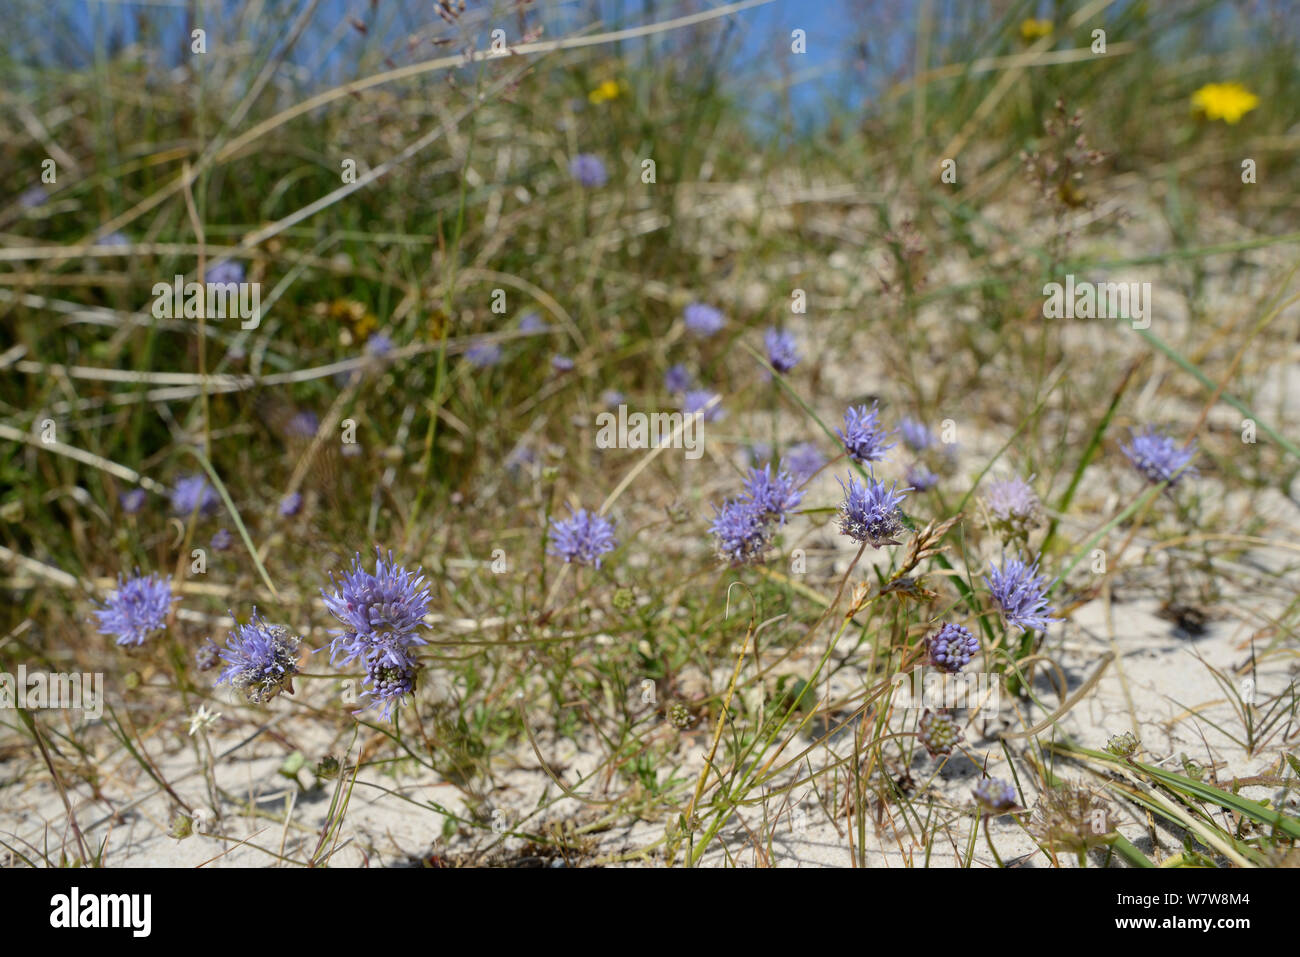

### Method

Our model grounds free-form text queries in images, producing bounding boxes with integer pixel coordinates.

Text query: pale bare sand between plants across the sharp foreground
[0,582,1300,867]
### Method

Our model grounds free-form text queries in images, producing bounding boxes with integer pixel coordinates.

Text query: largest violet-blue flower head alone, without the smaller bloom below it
[321,549,429,664]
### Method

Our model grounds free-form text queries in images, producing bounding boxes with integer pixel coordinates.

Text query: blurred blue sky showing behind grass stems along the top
[20,0,1258,129]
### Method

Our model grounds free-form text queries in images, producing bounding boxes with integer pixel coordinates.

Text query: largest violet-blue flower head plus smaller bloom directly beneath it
[321,549,429,718]
